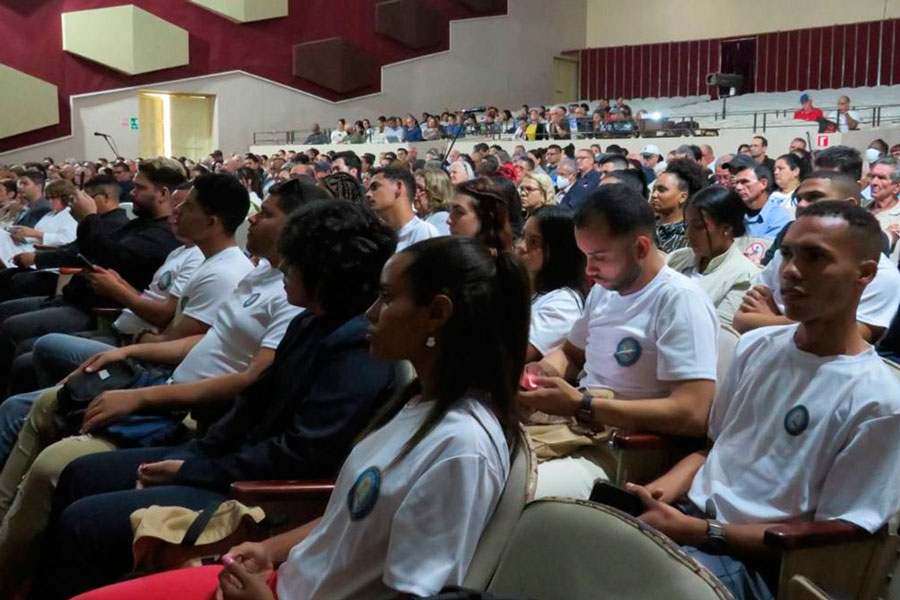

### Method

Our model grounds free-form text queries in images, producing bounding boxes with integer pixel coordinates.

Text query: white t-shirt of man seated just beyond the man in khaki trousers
[174,246,253,325]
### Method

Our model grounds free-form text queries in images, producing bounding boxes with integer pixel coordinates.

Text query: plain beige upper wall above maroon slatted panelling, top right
[586,0,900,48]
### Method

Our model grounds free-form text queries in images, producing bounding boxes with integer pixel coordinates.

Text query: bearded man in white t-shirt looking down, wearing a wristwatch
[520,184,719,498]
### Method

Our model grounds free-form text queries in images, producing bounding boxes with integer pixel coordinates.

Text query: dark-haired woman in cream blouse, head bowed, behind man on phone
[668,185,760,325]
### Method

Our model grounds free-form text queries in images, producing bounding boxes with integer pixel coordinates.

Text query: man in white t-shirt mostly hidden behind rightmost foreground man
[734,171,900,342]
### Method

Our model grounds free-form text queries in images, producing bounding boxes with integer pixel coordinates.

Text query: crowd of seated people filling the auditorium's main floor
[0,124,900,600]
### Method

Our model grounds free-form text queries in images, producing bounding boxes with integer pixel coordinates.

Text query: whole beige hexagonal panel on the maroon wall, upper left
[62,4,190,75]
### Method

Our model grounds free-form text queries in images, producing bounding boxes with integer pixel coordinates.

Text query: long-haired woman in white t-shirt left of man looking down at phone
[516,206,585,362]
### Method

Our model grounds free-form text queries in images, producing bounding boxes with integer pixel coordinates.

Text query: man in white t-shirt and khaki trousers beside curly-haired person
[0,181,325,584]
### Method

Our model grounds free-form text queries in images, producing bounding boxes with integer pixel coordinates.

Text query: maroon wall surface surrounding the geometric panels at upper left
[0,0,506,151]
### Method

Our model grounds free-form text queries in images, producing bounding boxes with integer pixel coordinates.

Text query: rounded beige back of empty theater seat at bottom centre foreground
[488,498,732,600]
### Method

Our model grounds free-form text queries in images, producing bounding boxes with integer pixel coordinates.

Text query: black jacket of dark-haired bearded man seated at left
[62,215,181,310]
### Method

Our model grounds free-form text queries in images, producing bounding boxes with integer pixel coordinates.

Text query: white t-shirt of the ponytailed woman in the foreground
[278,400,509,600]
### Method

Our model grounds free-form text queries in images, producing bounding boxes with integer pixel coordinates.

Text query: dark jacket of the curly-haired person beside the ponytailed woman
[174,312,395,491]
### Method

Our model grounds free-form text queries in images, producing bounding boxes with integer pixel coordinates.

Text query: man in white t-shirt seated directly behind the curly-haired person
[366,167,440,252]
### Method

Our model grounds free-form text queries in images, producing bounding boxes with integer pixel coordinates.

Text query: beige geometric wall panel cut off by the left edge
[0,65,59,138]
